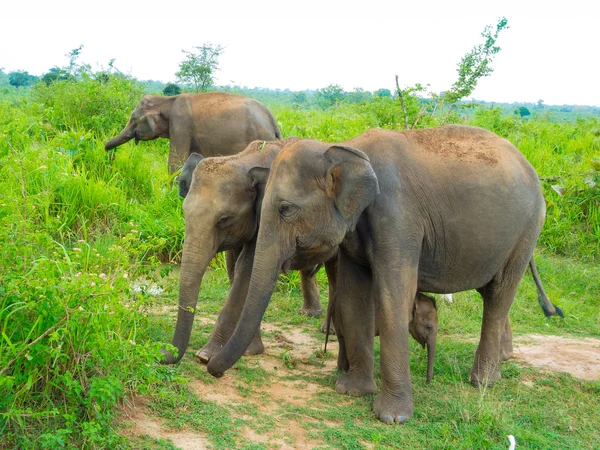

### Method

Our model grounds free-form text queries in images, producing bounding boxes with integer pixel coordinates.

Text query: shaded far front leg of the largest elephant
[334,254,377,396]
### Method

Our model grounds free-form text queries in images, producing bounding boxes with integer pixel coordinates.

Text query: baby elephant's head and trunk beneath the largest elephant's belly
[408,293,438,383]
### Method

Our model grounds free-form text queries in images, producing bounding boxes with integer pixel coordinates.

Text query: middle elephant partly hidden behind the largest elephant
[163,141,335,364]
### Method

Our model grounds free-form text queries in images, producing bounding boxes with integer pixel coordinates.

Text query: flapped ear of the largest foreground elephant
[325,145,379,231]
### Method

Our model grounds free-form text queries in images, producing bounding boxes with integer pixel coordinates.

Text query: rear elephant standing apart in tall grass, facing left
[104,92,281,174]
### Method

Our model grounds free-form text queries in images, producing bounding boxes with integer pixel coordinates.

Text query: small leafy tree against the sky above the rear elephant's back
[175,42,223,92]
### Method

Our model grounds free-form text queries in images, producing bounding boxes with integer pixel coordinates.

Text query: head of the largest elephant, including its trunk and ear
[208,140,379,377]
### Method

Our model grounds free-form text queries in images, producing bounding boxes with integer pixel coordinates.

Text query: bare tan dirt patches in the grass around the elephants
[122,323,600,450]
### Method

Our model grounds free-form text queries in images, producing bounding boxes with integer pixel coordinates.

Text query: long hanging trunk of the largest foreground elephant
[208,227,291,378]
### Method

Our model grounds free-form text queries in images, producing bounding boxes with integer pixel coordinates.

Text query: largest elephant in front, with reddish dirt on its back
[208,126,545,423]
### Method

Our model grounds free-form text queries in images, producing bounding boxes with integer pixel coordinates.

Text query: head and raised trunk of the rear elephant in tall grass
[104,95,171,150]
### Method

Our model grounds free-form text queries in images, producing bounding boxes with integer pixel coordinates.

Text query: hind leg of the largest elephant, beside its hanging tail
[470,249,533,387]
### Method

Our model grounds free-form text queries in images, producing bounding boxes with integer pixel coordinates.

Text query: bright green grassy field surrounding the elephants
[0,77,600,449]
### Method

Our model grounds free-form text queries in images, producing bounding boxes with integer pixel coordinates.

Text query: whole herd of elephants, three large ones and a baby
[105,93,562,423]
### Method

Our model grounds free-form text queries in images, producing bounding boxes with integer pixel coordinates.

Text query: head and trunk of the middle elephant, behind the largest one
[163,141,279,364]
